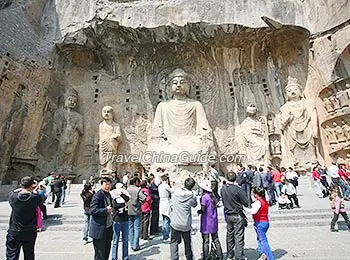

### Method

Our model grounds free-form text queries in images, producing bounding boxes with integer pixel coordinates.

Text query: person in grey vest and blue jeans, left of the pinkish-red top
[127,176,146,251]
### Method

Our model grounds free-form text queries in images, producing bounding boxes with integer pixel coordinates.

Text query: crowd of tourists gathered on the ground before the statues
[6,164,350,260]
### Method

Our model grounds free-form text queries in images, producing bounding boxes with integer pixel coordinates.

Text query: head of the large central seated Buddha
[169,69,190,97]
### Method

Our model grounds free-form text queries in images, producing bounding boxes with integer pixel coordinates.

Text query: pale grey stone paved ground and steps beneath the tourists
[0,176,350,260]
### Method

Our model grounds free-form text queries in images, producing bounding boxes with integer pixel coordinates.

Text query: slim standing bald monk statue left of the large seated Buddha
[98,106,121,175]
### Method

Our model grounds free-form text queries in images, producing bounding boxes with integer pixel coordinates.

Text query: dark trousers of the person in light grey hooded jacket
[170,228,193,260]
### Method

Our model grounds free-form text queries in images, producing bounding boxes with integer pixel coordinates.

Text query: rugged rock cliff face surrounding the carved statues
[0,0,350,182]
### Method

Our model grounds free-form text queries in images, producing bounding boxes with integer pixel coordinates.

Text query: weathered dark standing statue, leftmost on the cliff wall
[53,88,84,177]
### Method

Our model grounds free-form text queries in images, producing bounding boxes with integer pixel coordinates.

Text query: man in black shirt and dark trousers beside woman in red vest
[221,172,248,259]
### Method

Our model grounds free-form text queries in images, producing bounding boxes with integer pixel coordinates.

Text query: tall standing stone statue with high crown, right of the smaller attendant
[280,77,318,170]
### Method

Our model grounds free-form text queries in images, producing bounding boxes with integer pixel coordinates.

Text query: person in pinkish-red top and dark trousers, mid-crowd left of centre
[140,180,152,240]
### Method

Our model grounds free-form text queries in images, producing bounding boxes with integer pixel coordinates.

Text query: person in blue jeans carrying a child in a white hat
[111,182,130,260]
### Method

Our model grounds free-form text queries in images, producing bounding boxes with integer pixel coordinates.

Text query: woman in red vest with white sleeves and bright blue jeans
[251,188,275,260]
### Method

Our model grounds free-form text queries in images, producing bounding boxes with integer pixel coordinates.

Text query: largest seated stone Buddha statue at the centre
[148,69,213,160]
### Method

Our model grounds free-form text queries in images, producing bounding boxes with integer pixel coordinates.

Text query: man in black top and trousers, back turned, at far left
[6,176,41,260]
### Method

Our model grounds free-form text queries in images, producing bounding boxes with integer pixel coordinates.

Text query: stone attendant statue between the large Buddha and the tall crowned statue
[235,104,269,165]
